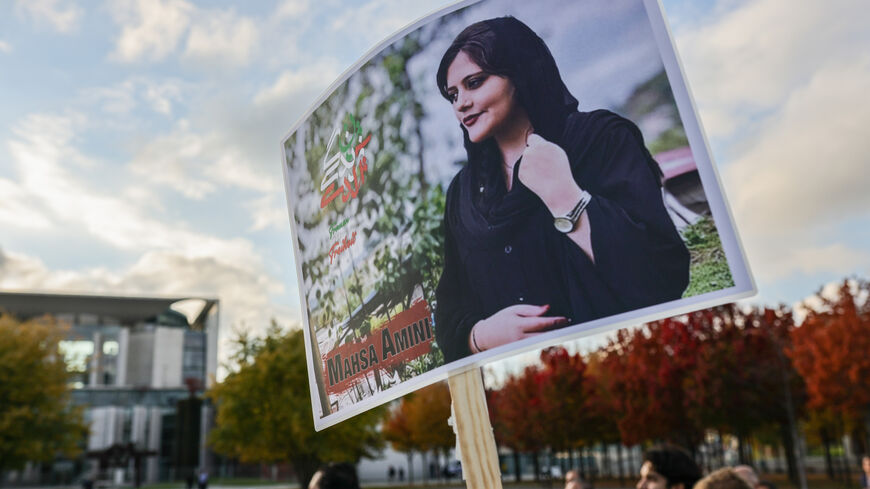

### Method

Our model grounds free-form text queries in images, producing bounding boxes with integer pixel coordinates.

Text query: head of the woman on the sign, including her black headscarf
[436,17,577,153]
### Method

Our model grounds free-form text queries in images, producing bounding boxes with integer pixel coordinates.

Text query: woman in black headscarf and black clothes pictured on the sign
[435,17,689,361]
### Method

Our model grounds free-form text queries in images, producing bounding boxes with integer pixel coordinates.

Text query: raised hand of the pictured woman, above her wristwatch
[519,133,581,216]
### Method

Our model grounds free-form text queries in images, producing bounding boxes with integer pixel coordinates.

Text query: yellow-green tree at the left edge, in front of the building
[0,314,88,471]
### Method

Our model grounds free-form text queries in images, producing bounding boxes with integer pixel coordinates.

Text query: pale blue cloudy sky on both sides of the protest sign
[0,0,870,376]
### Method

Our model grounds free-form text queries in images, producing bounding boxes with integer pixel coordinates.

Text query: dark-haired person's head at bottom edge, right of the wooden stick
[637,445,701,489]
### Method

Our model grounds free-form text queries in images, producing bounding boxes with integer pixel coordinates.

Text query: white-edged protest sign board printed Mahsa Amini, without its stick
[282,0,754,429]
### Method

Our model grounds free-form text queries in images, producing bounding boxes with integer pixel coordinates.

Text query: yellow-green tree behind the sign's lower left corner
[208,323,384,487]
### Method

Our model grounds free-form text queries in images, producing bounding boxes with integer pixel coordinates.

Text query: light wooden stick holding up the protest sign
[447,368,502,489]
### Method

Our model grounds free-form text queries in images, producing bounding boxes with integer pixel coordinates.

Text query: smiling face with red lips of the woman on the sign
[447,51,519,143]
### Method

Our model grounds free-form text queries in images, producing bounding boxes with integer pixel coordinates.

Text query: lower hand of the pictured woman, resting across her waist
[468,304,568,353]
